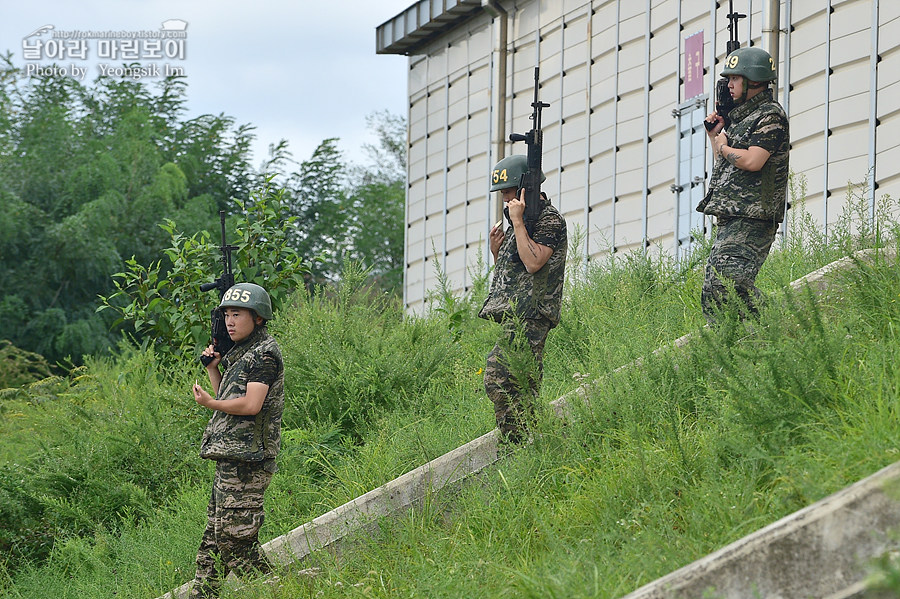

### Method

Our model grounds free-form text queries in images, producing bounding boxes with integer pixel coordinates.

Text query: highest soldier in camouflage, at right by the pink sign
[697,48,790,322]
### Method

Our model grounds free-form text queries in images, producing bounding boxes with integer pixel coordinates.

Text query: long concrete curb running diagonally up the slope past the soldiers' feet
[158,250,892,599]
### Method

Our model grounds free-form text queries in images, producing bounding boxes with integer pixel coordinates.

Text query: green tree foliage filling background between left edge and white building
[0,55,406,365]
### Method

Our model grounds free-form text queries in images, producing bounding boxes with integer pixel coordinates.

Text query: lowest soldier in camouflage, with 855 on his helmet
[191,283,284,597]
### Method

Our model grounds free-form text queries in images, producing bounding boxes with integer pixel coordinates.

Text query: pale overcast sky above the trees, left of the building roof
[0,0,413,169]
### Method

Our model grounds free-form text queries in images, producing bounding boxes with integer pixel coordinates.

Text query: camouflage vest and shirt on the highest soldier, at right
[697,89,790,223]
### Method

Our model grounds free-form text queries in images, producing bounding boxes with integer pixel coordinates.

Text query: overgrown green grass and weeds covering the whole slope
[0,179,900,599]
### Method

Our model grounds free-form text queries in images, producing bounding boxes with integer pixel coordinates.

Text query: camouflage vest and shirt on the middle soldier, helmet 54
[478,199,569,327]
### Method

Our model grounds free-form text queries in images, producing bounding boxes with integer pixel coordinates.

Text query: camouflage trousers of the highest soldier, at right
[700,217,778,323]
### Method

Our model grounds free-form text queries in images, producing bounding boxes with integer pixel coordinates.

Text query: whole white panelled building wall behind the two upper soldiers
[405,0,900,311]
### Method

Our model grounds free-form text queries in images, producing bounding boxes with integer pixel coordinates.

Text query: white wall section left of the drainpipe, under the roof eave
[405,10,492,309]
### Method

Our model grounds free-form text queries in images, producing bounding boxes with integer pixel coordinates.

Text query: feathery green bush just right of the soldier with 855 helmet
[276,265,461,439]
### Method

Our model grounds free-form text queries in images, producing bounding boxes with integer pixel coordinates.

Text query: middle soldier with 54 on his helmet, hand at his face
[478,156,568,443]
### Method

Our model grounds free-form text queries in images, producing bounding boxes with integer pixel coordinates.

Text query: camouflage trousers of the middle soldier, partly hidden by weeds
[484,319,550,443]
